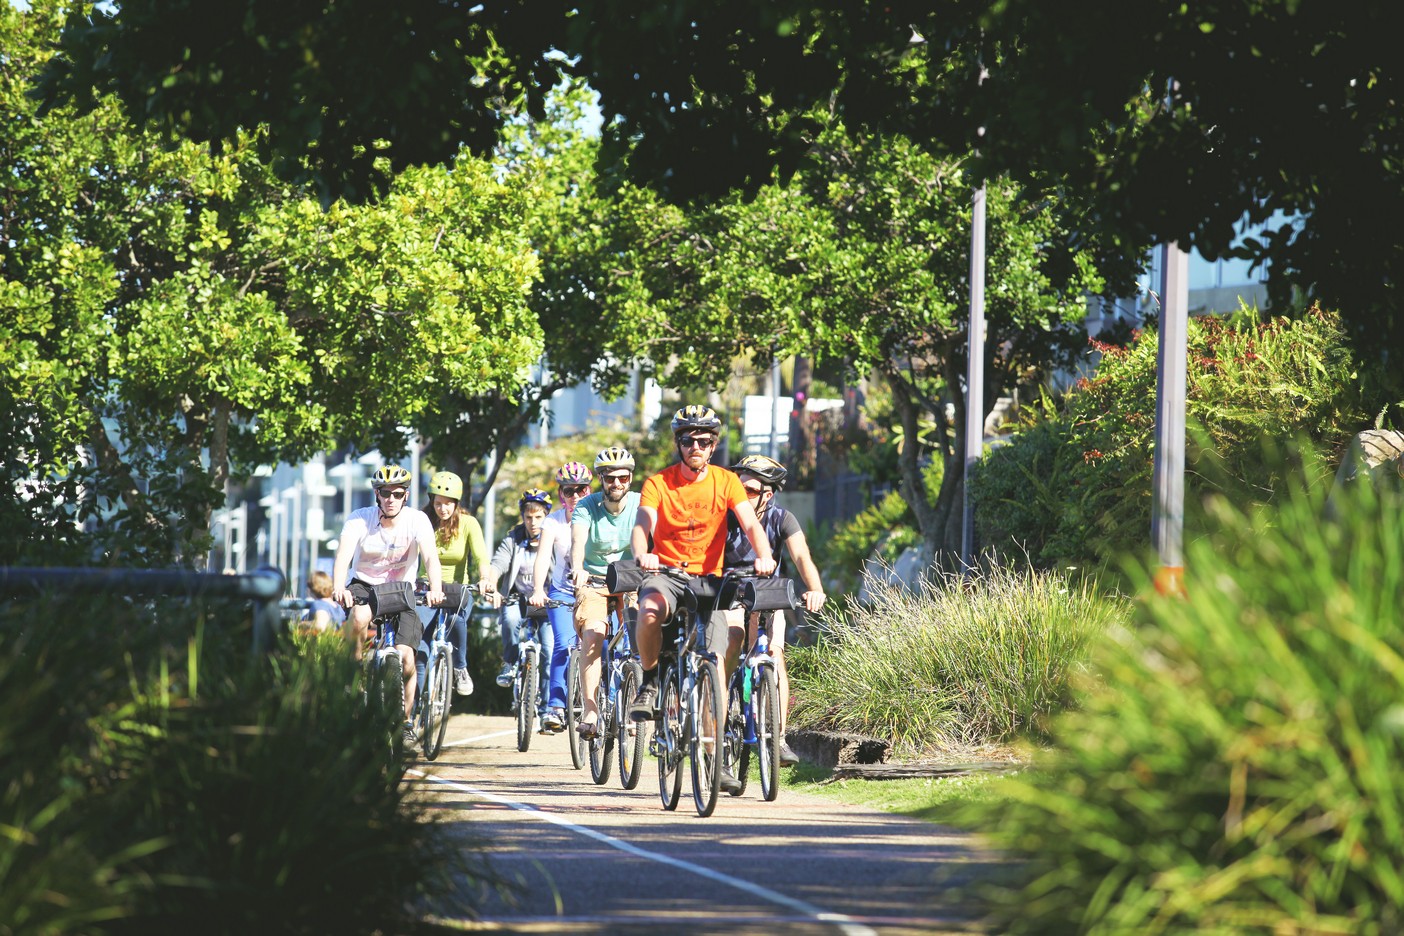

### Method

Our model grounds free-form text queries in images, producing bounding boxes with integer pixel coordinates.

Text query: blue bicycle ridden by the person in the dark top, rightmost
[724,578,797,803]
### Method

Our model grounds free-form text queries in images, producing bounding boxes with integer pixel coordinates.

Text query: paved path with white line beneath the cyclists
[409,714,988,936]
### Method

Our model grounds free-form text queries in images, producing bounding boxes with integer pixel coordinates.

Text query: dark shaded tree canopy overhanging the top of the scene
[45,0,1404,348]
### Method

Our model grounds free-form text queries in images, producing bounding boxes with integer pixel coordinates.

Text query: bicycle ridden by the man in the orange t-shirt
[650,567,726,818]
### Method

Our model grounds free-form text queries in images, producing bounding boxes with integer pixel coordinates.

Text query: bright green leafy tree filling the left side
[0,3,541,563]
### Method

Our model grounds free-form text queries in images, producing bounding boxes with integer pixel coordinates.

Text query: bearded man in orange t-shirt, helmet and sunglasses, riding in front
[629,404,775,793]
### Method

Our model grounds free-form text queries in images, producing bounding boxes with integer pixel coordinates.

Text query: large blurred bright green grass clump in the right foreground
[969,486,1404,933]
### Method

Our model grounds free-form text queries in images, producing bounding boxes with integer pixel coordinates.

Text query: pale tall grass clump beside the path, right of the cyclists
[790,568,1126,751]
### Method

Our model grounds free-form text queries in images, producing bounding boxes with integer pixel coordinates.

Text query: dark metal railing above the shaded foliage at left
[0,566,285,654]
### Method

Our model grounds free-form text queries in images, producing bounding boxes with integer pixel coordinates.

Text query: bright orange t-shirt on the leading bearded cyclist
[639,464,746,575]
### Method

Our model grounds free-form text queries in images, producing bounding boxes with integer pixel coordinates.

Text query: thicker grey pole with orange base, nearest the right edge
[1150,243,1189,595]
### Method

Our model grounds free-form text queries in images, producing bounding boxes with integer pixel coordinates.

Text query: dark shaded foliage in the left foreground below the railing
[0,601,475,933]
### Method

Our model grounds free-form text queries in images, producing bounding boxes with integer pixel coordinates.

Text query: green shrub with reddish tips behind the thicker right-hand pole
[972,309,1383,567]
